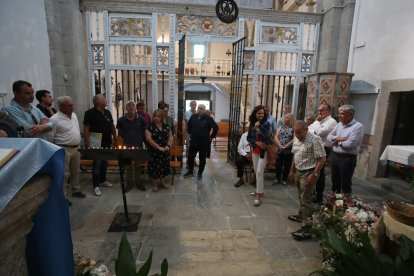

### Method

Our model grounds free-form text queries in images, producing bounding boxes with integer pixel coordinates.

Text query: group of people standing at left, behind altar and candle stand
[0,80,187,205]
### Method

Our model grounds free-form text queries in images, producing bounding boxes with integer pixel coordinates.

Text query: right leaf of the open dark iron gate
[227,37,244,163]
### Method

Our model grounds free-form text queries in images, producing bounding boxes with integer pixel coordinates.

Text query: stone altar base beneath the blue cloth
[0,175,52,275]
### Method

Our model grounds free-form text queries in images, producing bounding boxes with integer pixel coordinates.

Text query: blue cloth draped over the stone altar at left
[0,138,74,276]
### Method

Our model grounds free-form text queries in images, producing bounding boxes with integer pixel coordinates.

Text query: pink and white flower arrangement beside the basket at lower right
[307,192,383,271]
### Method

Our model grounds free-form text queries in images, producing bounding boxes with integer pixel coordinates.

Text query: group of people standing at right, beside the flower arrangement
[235,103,364,240]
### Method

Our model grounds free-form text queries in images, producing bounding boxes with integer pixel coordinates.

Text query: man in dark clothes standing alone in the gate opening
[184,104,218,180]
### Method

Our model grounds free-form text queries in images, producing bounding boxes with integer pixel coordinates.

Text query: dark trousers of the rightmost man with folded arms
[332,152,357,194]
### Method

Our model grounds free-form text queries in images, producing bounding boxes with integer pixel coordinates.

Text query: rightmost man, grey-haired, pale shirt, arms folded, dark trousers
[327,105,364,194]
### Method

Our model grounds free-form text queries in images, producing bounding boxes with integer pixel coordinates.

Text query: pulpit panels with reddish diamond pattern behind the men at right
[305,72,354,116]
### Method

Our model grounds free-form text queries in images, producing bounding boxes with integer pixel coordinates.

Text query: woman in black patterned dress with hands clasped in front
[145,109,172,192]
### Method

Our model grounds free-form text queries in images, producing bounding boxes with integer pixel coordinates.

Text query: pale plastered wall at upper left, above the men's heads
[0,0,52,106]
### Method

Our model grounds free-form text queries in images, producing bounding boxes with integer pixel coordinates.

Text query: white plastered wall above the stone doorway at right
[350,0,414,88]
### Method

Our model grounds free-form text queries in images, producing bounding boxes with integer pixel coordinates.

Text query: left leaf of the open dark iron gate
[177,35,185,146]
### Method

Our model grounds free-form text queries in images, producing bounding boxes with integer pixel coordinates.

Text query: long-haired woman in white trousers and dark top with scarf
[247,105,273,206]
